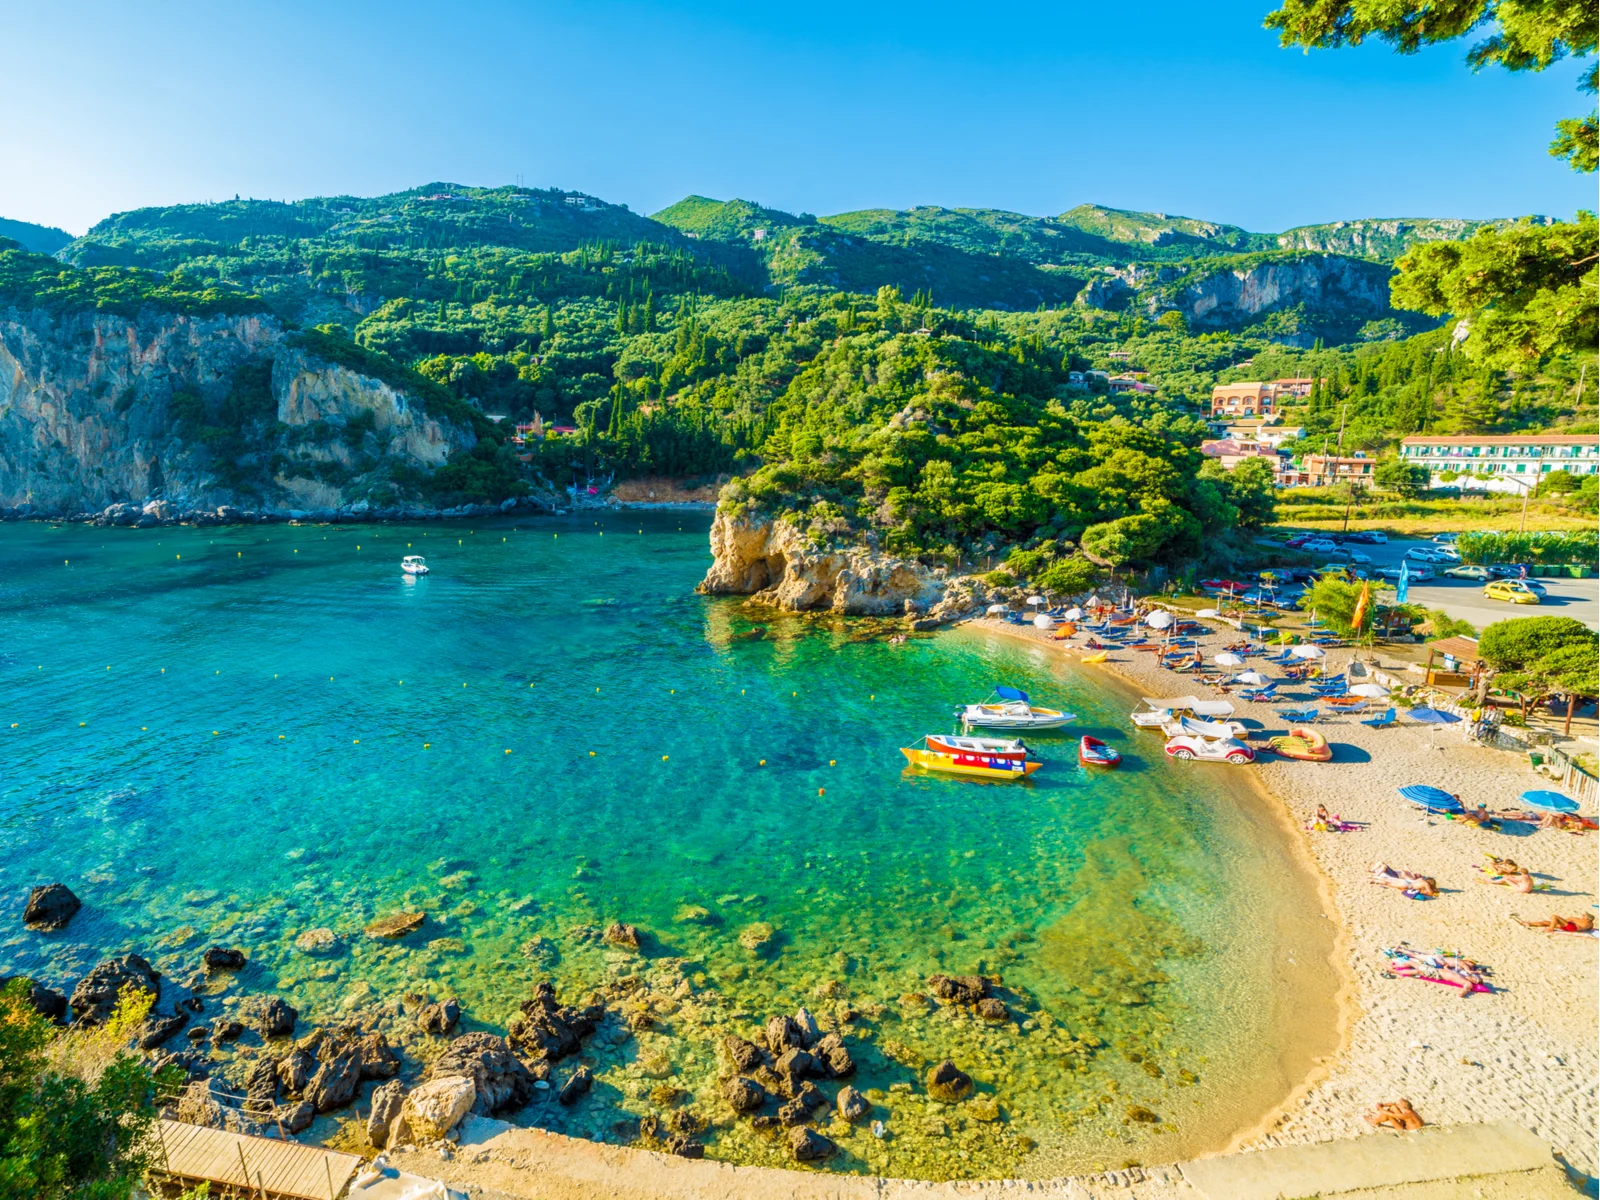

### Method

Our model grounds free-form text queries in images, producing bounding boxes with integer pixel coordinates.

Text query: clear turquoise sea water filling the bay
[0,512,1315,1176]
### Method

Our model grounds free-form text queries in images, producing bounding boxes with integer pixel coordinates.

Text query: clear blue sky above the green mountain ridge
[0,0,1595,234]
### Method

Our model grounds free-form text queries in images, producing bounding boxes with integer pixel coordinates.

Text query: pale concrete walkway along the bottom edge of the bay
[387,1118,1578,1200]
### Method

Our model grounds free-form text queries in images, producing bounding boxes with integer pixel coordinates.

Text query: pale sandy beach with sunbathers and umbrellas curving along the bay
[970,621,1600,1176]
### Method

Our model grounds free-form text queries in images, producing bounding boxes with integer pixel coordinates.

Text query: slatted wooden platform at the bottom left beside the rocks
[150,1120,362,1200]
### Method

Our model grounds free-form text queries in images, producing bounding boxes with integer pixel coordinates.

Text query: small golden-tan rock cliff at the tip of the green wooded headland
[698,510,978,618]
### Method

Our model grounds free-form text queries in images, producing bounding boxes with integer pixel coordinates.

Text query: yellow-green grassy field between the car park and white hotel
[1277,491,1595,538]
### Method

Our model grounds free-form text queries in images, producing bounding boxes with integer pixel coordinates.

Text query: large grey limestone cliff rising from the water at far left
[0,309,477,514]
